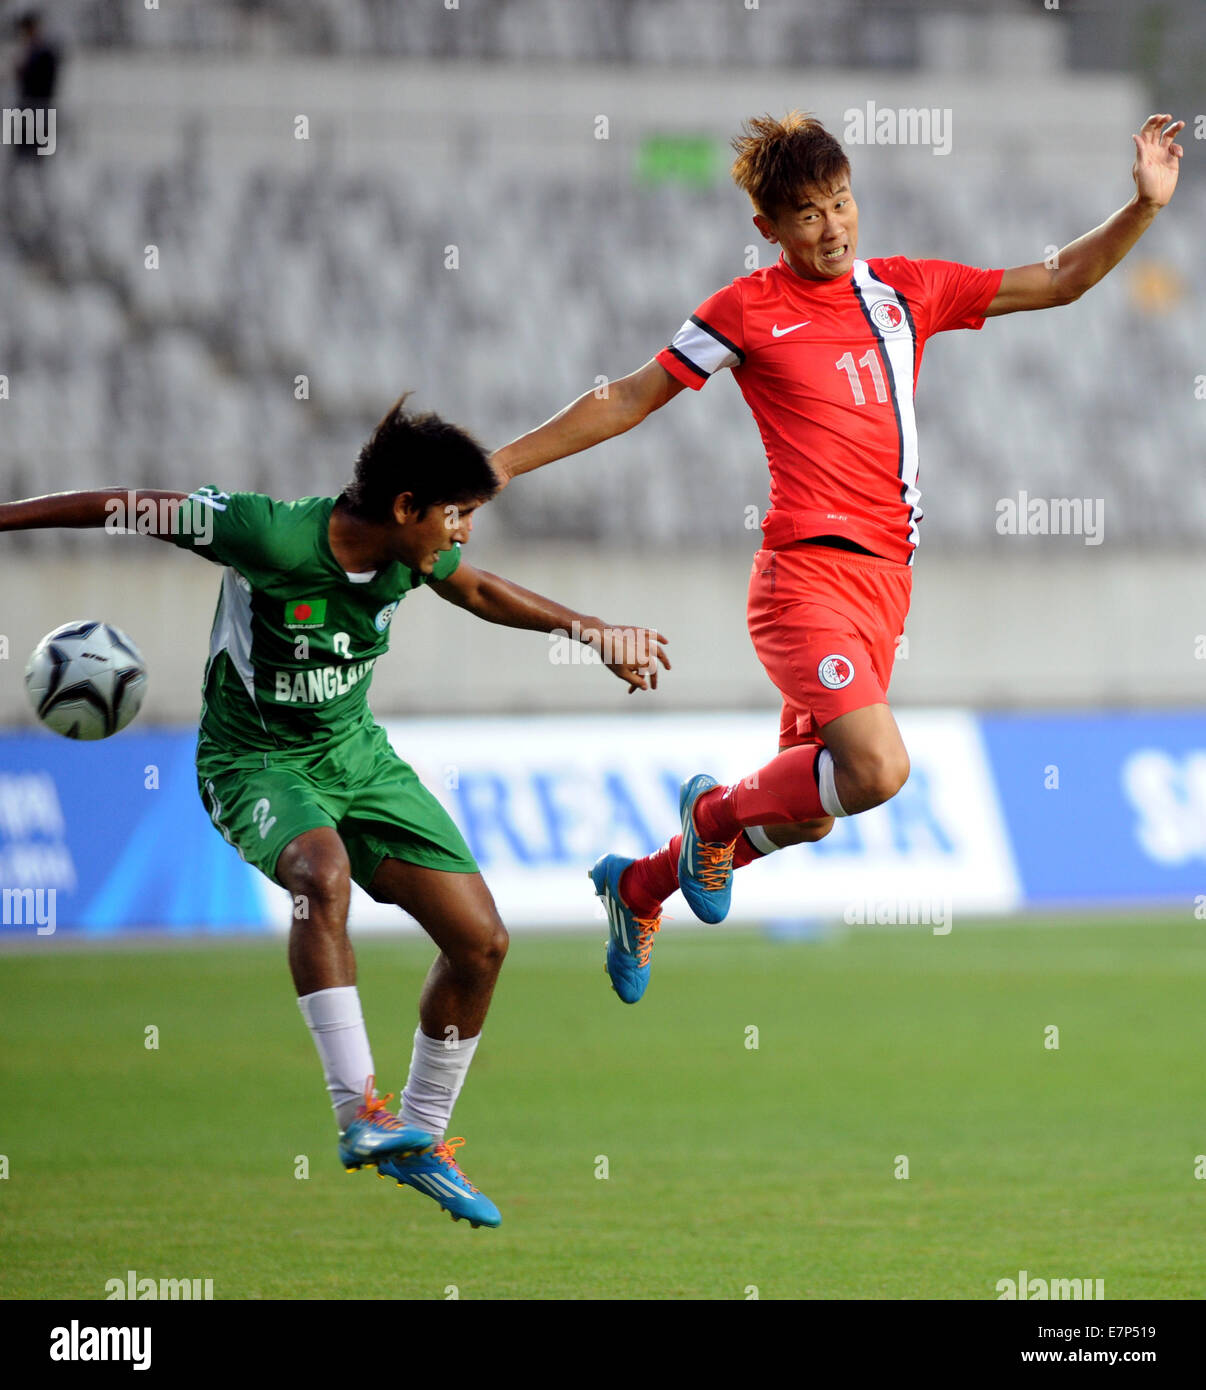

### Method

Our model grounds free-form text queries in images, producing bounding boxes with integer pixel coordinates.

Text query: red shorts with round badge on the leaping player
[746,545,913,748]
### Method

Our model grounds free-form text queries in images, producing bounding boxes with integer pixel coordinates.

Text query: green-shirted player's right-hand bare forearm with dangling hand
[431,562,670,695]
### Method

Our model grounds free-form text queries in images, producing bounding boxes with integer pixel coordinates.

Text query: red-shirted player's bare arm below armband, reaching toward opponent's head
[490,359,682,487]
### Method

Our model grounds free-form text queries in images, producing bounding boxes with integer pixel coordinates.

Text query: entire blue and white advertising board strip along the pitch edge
[0,710,1206,937]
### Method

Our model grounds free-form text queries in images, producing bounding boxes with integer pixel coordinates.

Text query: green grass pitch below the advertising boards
[0,917,1206,1300]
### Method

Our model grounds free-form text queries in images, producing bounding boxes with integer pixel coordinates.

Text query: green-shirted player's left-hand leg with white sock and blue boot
[276,827,435,1170]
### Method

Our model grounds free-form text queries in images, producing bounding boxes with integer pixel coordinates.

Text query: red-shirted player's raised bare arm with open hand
[985,114,1185,318]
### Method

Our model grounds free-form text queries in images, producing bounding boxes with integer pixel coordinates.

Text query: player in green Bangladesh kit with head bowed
[0,398,670,1226]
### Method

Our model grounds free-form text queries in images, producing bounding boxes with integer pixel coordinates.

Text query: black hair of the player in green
[339,392,499,521]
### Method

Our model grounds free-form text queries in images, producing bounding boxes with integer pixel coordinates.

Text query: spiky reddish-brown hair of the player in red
[731,111,850,217]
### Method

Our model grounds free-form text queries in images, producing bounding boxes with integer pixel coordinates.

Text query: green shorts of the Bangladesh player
[197,724,478,888]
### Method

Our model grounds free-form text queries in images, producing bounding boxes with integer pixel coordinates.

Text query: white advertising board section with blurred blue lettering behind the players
[345,709,1021,931]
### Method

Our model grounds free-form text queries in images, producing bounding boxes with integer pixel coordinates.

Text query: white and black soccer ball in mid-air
[25,621,146,739]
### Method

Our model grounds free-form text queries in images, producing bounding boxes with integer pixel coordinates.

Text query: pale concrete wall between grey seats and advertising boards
[0,536,1206,726]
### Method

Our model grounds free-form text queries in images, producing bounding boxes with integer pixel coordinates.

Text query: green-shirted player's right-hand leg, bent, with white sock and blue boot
[370,859,509,1226]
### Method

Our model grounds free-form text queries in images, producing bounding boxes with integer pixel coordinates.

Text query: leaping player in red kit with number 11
[492,113,1185,1002]
